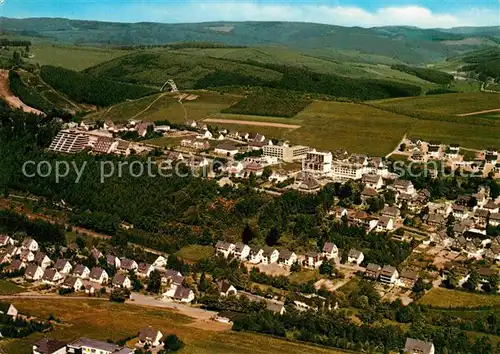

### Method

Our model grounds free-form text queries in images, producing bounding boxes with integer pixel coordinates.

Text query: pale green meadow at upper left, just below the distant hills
[27,44,130,70]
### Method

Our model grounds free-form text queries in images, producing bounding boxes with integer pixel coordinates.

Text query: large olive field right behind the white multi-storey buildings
[288,101,415,156]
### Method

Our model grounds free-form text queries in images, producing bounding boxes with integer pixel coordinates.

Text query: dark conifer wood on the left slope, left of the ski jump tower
[40,65,156,106]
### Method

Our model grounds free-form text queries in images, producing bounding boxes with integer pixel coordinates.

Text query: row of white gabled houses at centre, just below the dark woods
[215,241,339,269]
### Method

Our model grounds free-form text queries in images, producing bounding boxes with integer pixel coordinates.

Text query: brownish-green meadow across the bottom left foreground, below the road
[0,299,343,354]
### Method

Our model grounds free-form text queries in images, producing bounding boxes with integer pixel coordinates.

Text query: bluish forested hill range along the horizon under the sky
[2,18,500,64]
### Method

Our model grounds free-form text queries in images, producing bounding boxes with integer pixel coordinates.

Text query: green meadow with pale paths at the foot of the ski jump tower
[88,91,241,123]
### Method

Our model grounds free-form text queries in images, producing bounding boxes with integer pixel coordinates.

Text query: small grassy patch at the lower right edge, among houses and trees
[419,288,500,308]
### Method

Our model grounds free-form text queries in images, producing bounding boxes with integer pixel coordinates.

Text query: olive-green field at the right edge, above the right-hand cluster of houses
[371,92,500,115]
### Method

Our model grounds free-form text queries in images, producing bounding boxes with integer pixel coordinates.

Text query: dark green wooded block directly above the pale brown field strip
[222,90,311,118]
